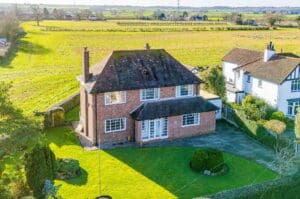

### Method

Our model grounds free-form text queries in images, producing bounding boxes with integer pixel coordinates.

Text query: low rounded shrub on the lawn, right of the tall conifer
[57,158,81,180]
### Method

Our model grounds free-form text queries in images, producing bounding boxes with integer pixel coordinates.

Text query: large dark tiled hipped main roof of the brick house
[85,49,202,93]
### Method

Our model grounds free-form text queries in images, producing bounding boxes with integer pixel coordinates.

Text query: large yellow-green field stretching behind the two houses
[0,21,300,113]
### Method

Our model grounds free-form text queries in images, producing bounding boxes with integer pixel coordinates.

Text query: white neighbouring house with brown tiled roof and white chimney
[222,42,300,118]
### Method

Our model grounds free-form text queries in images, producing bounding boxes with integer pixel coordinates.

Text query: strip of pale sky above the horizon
[0,0,300,7]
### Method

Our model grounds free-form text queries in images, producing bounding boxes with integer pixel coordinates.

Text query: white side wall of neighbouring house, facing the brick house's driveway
[252,77,278,108]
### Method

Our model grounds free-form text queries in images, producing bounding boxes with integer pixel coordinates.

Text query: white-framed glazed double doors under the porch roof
[141,117,169,141]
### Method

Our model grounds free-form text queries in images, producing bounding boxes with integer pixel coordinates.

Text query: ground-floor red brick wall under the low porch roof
[136,111,216,144]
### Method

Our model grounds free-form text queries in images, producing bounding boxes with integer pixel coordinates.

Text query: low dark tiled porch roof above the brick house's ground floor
[130,96,219,121]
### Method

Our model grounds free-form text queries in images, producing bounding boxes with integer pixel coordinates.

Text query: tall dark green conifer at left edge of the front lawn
[25,144,57,199]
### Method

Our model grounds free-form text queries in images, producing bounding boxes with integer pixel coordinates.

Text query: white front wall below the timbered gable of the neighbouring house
[277,81,300,115]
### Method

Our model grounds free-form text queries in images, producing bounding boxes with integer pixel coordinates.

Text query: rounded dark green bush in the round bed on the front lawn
[190,148,225,173]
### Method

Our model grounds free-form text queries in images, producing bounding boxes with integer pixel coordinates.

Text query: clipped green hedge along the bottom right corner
[203,171,300,199]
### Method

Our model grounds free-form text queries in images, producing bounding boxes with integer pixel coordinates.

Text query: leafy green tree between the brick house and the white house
[202,66,226,98]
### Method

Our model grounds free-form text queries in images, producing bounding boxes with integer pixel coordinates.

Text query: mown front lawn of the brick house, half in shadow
[46,127,277,199]
